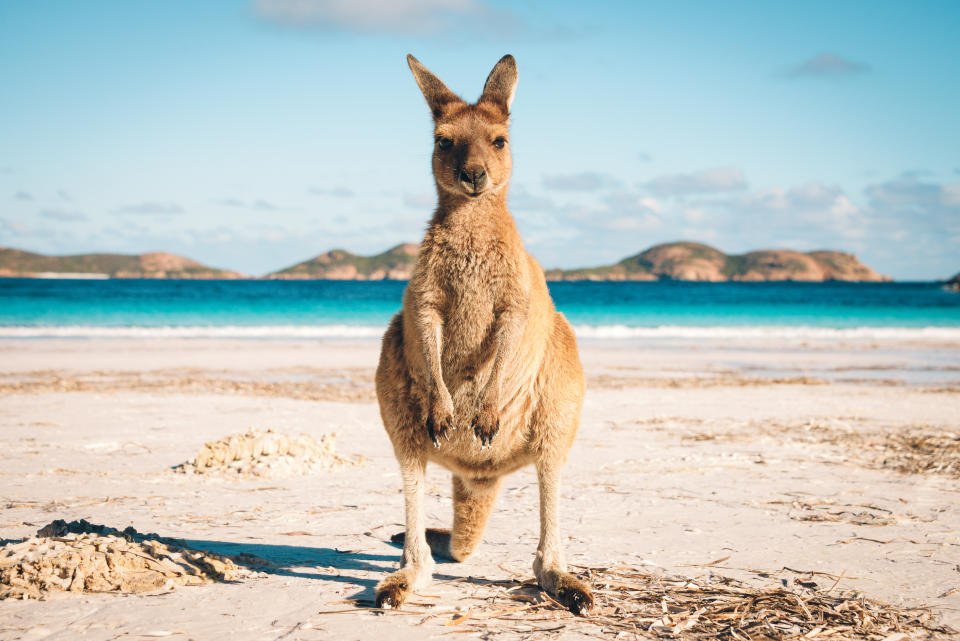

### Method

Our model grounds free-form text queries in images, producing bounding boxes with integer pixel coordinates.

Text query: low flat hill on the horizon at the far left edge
[0,247,246,279]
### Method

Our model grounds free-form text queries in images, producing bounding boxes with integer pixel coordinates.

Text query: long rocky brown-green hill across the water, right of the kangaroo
[547,242,890,282]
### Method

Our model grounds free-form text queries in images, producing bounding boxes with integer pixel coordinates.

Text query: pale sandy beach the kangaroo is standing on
[0,333,960,641]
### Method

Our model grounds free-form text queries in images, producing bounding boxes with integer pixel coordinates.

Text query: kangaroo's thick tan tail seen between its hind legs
[390,476,502,561]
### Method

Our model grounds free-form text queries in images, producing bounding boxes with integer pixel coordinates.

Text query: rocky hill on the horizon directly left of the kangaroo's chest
[266,243,420,280]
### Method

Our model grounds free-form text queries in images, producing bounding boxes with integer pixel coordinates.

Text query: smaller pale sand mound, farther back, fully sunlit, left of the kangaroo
[173,429,363,477]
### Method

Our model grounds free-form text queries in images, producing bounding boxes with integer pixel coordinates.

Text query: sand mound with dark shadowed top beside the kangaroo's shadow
[0,520,246,599]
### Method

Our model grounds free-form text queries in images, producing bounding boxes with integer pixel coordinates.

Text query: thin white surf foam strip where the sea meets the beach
[0,325,960,341]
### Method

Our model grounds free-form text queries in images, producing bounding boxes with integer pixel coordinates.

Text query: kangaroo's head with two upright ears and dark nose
[407,55,517,198]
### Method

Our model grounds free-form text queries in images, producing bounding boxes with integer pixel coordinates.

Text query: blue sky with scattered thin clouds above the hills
[0,0,960,279]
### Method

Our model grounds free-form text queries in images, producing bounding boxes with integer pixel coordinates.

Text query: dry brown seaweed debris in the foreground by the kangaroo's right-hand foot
[434,567,957,641]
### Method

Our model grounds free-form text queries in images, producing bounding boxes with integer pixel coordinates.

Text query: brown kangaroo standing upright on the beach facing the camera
[376,55,593,614]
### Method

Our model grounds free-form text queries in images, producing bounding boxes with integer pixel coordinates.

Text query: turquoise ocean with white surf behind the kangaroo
[0,278,960,340]
